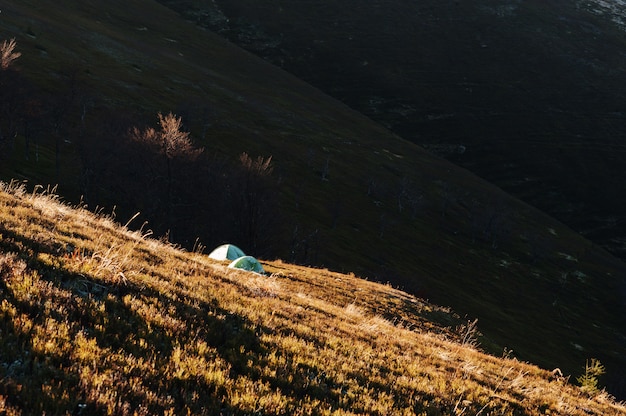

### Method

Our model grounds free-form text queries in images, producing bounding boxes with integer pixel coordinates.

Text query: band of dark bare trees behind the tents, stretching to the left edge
[0,57,280,255]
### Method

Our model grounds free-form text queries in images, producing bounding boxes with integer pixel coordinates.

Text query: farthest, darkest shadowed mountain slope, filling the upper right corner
[161,0,626,256]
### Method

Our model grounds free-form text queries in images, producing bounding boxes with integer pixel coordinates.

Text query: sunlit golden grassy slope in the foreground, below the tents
[0,184,626,416]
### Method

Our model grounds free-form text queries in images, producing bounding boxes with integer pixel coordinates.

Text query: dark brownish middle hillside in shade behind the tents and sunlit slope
[0,0,626,392]
